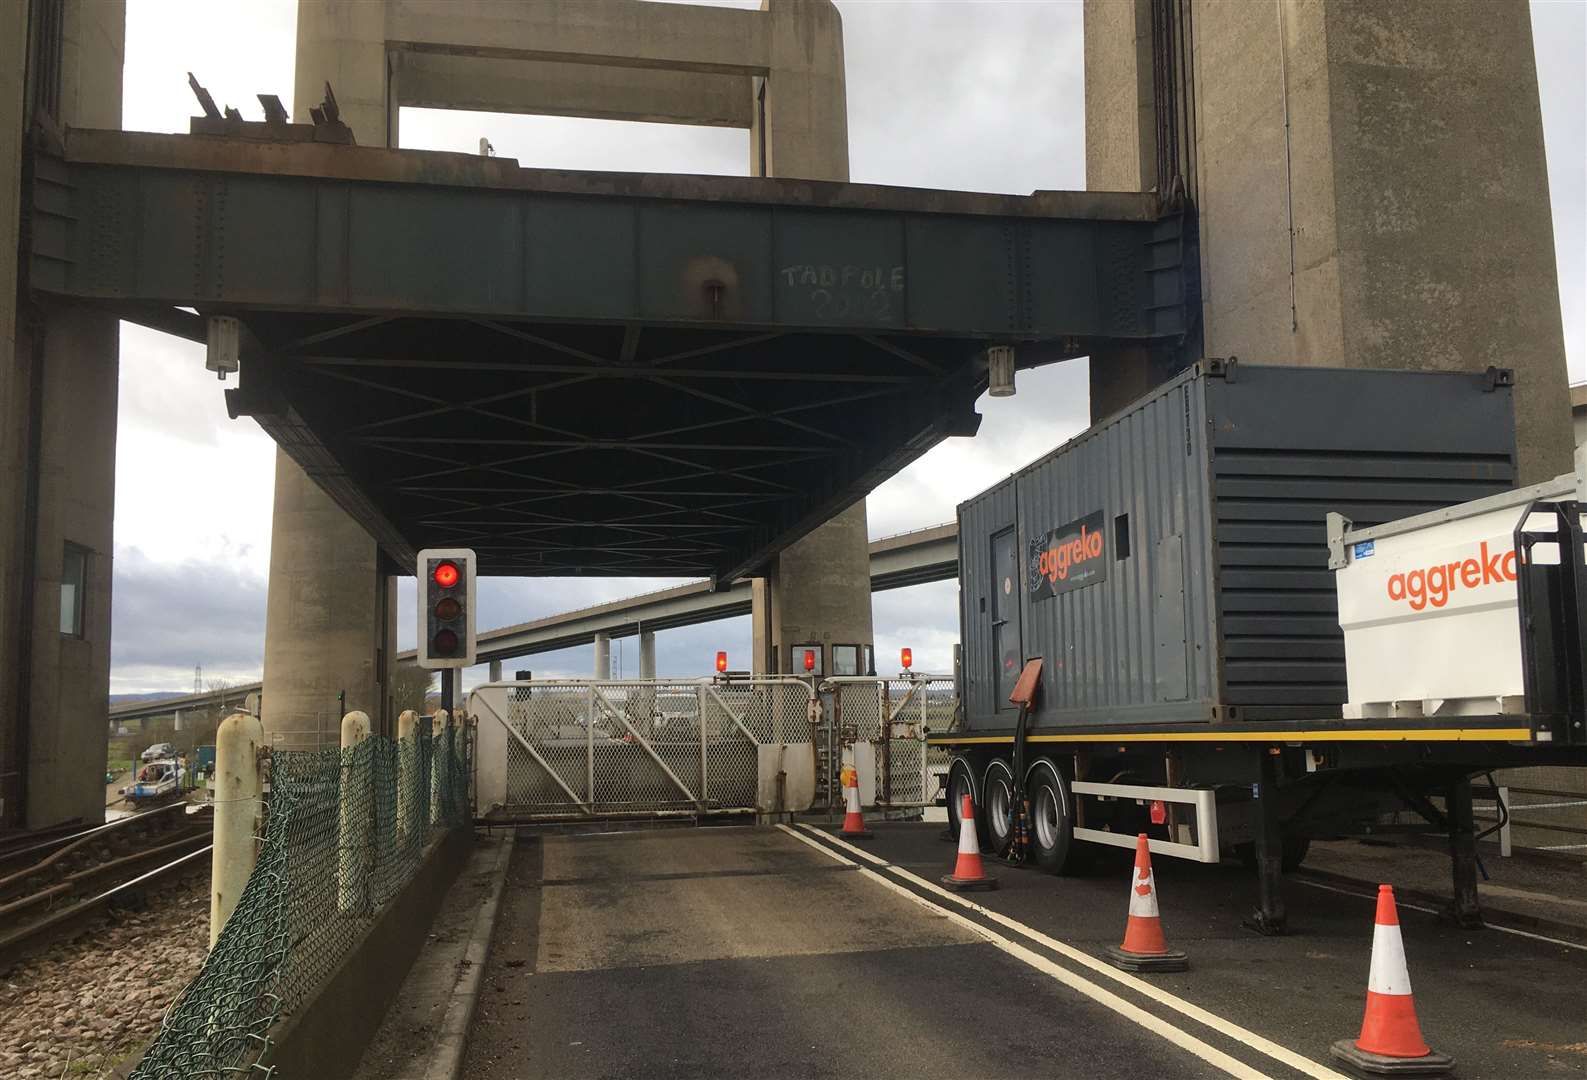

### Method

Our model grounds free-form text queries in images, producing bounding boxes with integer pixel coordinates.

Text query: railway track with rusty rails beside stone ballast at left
[0,802,213,974]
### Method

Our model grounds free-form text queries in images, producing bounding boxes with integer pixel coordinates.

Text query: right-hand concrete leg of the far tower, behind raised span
[749,0,873,672]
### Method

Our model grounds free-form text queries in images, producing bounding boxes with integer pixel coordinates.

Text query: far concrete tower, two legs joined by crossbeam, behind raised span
[263,0,871,733]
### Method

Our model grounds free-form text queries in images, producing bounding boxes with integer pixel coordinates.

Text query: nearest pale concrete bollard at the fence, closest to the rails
[209,712,265,948]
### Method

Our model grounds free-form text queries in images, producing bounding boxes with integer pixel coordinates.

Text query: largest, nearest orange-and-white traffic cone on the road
[1330,885,1455,1077]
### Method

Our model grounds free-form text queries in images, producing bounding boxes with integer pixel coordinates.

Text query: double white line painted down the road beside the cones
[778,825,1349,1080]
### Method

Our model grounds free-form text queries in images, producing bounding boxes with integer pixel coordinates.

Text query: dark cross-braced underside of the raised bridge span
[232,312,984,580]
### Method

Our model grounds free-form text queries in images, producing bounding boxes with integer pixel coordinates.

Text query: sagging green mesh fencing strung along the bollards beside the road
[132,720,471,1080]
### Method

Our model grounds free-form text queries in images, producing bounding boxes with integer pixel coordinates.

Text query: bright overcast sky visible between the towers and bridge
[111,0,1587,693]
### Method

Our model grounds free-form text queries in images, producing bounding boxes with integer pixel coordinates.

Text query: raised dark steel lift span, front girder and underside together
[29,130,1195,582]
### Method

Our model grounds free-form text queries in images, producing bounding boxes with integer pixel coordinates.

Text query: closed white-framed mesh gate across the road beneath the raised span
[468,677,814,817]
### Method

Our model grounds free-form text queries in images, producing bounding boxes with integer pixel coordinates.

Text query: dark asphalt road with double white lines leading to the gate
[463,825,1587,1080]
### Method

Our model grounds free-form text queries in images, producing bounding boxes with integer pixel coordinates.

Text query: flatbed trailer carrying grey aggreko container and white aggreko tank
[928,362,1587,933]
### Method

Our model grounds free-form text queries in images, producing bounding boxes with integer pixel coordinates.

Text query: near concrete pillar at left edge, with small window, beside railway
[0,0,125,826]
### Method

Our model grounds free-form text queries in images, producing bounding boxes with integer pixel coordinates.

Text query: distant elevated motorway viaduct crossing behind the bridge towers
[110,522,959,725]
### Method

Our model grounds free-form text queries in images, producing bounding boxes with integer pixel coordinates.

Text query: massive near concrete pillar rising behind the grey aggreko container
[1086,0,1571,484]
